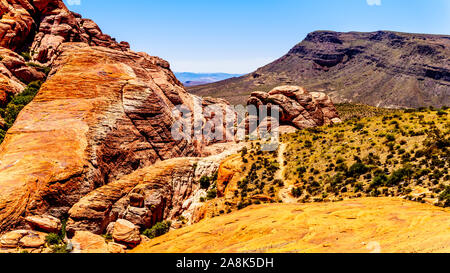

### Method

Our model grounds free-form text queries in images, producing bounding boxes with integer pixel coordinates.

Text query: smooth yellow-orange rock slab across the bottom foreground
[132,198,450,253]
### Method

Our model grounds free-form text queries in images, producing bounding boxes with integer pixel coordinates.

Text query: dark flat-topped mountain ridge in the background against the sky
[189,31,450,108]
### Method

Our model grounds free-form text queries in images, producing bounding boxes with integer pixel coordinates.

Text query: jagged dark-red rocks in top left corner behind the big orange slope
[0,0,129,107]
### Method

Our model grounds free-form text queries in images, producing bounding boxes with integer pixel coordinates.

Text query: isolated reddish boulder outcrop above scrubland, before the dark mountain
[247,86,342,129]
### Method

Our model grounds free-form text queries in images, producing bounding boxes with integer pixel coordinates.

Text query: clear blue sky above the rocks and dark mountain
[64,0,450,73]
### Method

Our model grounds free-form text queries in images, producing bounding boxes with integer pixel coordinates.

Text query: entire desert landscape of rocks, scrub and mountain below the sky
[0,0,450,253]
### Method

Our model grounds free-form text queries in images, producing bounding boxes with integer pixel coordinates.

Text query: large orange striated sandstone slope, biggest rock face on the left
[0,43,202,232]
